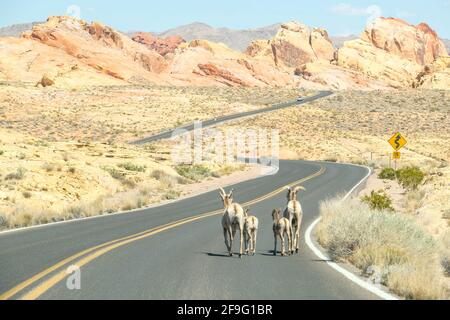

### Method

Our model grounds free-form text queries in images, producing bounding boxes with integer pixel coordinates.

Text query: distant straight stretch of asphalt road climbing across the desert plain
[132,91,333,145]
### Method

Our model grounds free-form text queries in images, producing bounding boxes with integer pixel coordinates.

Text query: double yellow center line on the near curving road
[0,167,326,300]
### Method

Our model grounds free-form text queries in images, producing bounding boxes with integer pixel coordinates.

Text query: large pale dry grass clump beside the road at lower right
[316,199,449,299]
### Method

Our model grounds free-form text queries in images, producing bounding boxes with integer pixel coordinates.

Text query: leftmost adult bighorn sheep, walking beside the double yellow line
[220,188,245,258]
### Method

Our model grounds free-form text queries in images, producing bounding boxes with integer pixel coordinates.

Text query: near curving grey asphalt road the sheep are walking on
[0,90,378,300]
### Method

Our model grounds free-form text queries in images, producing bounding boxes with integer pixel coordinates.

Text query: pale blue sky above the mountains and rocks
[0,0,450,38]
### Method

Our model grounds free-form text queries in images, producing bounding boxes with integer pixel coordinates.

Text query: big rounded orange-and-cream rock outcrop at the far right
[337,18,450,89]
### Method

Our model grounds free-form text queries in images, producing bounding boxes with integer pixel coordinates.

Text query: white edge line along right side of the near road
[305,166,398,300]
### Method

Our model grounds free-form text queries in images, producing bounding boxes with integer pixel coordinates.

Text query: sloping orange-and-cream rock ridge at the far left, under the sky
[23,17,167,82]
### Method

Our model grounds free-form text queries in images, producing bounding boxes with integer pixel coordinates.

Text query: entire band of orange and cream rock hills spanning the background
[0,17,450,90]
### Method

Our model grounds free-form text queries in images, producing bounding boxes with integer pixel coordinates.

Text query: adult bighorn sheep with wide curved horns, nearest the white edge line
[283,187,306,253]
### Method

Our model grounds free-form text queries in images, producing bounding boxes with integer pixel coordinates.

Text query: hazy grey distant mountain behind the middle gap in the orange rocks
[158,22,281,51]
